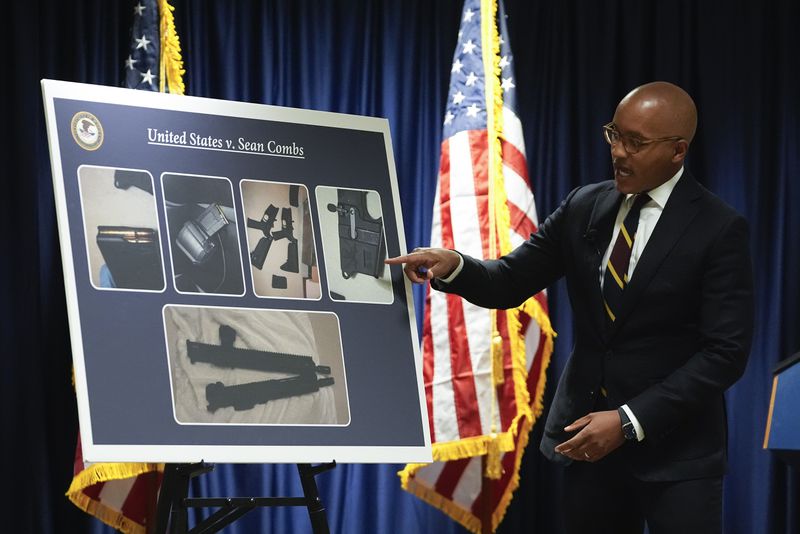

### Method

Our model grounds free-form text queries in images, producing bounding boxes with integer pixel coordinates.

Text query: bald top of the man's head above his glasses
[617,82,697,143]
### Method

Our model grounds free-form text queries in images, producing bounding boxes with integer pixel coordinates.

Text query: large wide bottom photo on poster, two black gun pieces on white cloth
[163,305,350,426]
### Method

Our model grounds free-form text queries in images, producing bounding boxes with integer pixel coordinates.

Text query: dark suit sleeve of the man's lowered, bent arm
[627,215,754,441]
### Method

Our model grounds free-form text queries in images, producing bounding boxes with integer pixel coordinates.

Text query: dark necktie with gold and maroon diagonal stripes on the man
[603,193,650,324]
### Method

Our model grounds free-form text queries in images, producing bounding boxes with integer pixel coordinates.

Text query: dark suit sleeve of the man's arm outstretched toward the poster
[431,188,581,309]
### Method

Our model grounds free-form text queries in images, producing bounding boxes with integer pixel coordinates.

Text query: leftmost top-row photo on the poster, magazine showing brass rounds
[78,165,165,291]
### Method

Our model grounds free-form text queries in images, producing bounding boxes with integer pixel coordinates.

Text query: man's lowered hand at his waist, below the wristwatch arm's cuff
[555,410,625,462]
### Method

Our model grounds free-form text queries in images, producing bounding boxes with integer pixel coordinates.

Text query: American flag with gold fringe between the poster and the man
[400,0,554,532]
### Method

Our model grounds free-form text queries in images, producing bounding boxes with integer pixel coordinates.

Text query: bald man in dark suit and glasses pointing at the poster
[387,82,753,534]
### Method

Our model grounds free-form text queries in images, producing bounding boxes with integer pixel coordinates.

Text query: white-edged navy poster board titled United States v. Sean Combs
[42,80,431,463]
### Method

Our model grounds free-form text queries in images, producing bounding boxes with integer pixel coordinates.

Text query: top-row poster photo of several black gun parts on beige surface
[239,180,322,300]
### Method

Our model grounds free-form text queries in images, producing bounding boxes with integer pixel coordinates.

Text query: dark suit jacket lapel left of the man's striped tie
[584,186,624,337]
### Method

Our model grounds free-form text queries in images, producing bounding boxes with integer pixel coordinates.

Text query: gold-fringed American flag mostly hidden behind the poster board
[67,0,184,534]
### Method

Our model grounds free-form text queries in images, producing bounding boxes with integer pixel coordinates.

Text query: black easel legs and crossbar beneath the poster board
[153,462,336,534]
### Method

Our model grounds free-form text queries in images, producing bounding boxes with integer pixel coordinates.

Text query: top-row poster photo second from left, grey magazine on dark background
[161,173,244,295]
